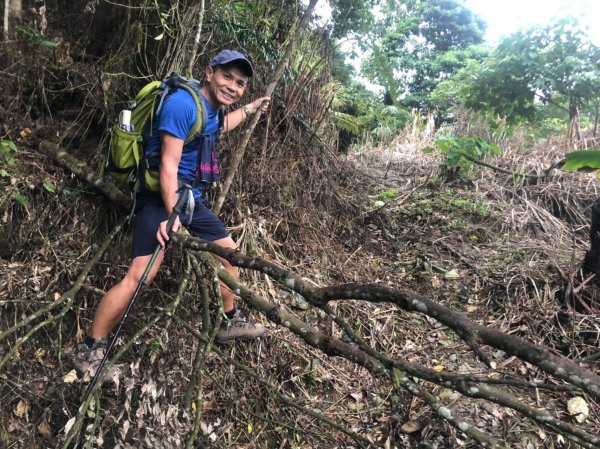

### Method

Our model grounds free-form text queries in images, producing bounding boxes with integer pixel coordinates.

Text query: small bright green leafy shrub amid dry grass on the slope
[423,136,502,173]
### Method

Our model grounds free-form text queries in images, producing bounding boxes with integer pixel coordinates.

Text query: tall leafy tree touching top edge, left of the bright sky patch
[362,0,487,109]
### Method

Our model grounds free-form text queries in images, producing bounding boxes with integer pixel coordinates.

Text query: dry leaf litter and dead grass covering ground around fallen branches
[0,109,600,448]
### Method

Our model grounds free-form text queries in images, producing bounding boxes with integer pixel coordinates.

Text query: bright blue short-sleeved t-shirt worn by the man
[146,89,219,179]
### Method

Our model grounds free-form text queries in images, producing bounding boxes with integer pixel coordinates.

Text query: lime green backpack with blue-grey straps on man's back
[104,75,206,191]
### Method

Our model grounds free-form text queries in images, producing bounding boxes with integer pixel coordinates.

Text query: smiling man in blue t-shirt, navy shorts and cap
[75,50,270,379]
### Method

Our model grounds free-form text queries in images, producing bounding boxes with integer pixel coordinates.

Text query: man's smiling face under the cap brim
[206,64,248,107]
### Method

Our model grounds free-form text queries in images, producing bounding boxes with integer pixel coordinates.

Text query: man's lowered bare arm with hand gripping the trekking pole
[156,132,183,248]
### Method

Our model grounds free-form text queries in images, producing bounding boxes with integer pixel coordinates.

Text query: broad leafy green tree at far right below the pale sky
[466,18,600,122]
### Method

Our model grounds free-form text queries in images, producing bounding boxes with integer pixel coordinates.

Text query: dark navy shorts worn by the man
[132,192,229,258]
